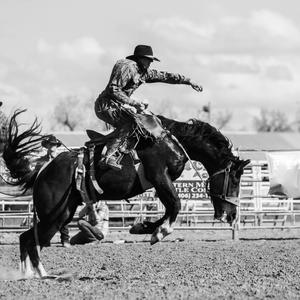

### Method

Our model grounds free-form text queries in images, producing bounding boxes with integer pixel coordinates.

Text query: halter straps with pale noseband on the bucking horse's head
[206,161,239,206]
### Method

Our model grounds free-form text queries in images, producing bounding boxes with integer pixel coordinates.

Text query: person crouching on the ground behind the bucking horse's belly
[70,201,109,245]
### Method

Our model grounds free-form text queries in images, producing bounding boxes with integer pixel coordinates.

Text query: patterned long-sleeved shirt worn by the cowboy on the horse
[99,59,190,105]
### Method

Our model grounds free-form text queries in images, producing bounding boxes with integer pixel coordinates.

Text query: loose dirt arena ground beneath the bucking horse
[0,230,300,299]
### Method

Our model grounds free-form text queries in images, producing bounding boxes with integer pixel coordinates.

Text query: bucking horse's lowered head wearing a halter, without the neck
[208,157,250,224]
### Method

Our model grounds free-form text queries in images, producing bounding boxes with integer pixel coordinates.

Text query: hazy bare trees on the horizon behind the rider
[42,96,300,132]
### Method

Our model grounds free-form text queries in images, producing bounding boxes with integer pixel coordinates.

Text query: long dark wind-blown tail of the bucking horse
[3,109,42,193]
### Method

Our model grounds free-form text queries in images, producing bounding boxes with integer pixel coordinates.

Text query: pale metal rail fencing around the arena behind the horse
[0,155,300,238]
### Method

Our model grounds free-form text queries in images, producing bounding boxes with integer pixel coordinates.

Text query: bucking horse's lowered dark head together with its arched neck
[159,116,250,223]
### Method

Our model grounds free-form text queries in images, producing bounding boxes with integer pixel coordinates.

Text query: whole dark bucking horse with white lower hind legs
[3,111,249,277]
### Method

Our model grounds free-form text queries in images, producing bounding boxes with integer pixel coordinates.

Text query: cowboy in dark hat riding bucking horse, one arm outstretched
[95,45,202,170]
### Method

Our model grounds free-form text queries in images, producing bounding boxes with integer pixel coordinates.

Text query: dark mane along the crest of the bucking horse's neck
[157,115,233,162]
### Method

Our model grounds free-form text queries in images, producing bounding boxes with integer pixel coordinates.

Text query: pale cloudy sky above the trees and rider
[0,0,300,131]
